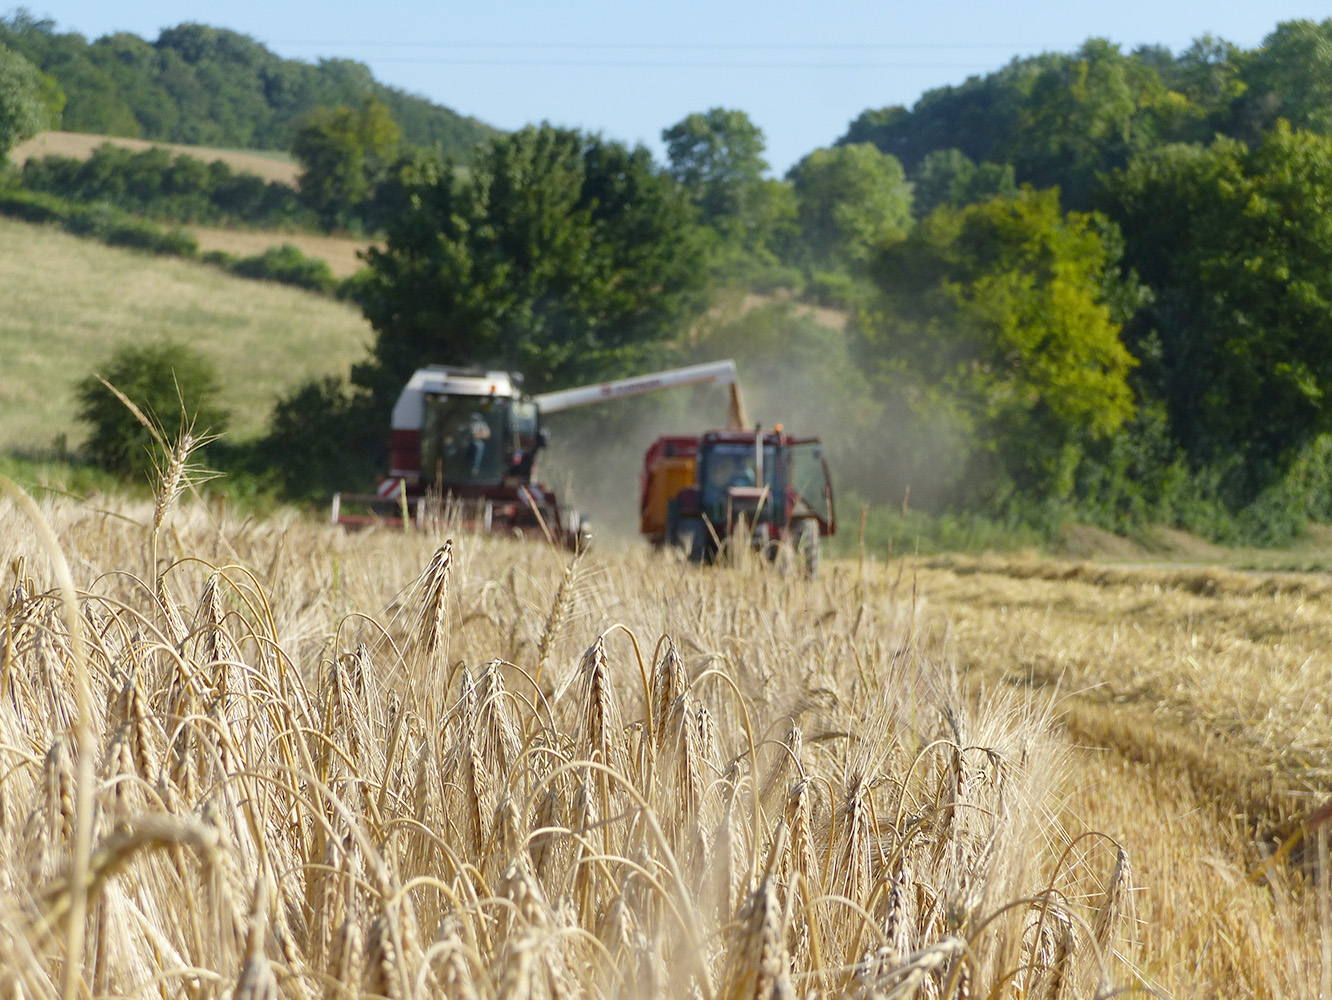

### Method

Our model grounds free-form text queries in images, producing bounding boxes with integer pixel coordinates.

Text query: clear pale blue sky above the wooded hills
[10,0,1329,174]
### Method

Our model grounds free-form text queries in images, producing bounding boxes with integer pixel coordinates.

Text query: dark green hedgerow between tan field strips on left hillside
[21,142,317,228]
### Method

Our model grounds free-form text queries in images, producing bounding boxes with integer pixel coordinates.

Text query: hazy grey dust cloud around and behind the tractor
[538,304,967,541]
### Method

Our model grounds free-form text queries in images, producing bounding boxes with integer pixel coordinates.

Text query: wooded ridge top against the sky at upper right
[839,20,1332,208]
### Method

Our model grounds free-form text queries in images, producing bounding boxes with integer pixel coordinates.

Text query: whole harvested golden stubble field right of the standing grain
[907,559,1332,1000]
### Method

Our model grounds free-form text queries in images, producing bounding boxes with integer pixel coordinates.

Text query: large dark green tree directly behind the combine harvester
[348,125,705,402]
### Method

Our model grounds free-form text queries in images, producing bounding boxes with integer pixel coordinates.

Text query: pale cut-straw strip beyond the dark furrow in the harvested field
[919,567,1332,804]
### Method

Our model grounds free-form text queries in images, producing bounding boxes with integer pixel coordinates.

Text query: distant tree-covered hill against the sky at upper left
[0,11,497,161]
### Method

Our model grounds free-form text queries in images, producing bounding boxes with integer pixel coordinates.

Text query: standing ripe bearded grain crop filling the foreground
[0,450,1188,999]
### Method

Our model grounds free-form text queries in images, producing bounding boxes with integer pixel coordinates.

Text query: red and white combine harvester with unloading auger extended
[333,361,749,549]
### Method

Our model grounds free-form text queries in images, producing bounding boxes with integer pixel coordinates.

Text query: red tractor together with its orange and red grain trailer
[639,425,836,575]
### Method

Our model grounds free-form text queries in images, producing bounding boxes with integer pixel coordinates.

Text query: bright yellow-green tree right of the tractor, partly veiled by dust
[864,189,1134,506]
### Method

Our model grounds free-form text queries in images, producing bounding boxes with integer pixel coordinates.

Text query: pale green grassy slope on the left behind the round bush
[0,220,370,449]
